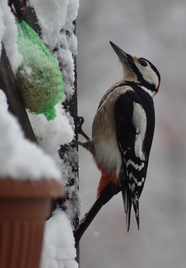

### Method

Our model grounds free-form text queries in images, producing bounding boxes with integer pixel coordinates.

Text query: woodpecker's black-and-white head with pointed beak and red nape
[110,41,161,96]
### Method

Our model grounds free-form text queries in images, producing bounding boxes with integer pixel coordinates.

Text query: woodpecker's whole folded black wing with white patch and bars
[114,90,155,230]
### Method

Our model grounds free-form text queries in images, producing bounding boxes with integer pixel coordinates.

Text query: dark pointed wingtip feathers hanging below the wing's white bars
[122,187,139,231]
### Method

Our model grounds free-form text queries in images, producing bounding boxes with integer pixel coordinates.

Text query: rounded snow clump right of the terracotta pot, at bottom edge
[40,209,78,268]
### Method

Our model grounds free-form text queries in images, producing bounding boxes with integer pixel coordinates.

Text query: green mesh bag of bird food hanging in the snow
[16,19,64,120]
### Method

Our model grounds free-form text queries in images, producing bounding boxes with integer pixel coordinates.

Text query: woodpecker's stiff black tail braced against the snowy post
[74,183,121,247]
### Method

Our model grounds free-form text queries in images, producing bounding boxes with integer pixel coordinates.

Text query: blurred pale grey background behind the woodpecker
[77,0,186,268]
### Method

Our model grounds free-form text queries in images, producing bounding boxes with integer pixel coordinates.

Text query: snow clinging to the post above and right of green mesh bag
[31,0,79,99]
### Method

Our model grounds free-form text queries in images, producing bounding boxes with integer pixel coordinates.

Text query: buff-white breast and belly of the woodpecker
[92,84,129,175]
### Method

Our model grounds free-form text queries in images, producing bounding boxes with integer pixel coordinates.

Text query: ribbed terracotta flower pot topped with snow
[0,179,64,268]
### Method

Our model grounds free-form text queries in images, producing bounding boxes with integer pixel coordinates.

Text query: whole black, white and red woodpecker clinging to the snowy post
[74,42,161,246]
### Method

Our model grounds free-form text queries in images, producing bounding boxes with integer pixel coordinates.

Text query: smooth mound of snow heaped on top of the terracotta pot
[0,90,61,180]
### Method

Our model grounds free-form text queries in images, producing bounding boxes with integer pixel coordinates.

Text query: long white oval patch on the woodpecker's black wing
[132,102,147,160]
